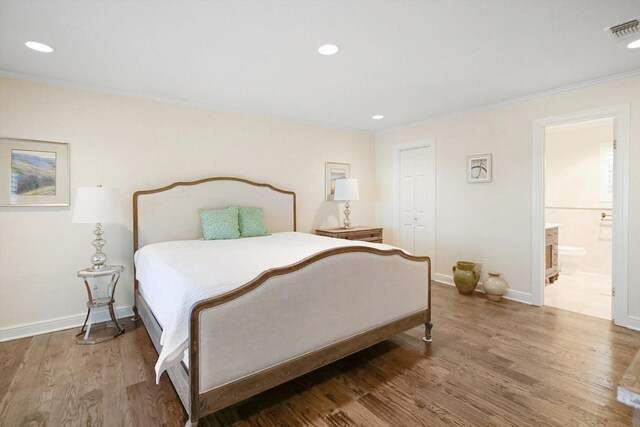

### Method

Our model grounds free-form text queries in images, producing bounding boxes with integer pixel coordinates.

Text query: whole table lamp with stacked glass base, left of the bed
[72,185,122,270]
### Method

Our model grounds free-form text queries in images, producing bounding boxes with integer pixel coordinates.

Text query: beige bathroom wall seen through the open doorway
[545,119,614,275]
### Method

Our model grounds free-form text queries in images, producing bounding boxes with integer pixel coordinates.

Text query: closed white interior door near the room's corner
[399,146,435,257]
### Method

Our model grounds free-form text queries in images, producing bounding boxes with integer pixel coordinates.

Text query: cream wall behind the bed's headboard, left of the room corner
[0,78,375,332]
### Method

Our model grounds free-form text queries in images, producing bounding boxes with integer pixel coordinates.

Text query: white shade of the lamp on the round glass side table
[73,187,122,224]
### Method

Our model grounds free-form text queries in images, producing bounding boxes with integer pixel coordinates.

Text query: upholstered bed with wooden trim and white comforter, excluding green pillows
[133,177,432,426]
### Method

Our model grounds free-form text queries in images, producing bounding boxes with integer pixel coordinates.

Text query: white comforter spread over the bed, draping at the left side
[135,232,393,381]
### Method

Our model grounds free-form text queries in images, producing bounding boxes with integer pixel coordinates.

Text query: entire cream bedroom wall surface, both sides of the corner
[5,77,640,333]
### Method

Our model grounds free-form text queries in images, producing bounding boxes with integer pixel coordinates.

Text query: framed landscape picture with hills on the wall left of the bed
[0,138,69,206]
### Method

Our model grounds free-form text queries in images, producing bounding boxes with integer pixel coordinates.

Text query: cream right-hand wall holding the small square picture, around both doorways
[376,77,640,316]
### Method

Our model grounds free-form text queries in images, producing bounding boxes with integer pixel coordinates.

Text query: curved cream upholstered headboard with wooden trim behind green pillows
[133,177,296,252]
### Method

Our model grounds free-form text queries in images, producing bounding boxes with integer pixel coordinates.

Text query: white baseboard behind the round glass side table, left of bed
[0,306,133,342]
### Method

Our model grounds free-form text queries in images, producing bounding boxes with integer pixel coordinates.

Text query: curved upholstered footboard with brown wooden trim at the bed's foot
[184,246,431,425]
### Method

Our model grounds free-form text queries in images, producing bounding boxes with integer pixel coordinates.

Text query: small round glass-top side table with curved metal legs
[76,265,124,344]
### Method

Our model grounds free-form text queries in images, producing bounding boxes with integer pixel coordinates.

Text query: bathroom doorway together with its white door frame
[531,104,640,329]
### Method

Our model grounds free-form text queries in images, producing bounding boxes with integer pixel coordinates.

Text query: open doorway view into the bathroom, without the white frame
[544,117,615,320]
